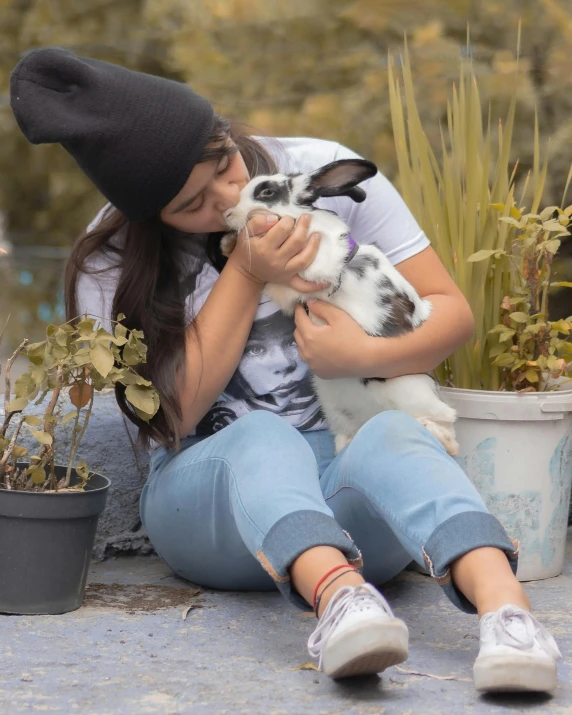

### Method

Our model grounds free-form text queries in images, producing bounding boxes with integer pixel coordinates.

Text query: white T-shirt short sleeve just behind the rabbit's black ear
[326,144,430,265]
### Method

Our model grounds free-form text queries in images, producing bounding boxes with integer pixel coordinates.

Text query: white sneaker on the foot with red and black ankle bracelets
[308,583,409,678]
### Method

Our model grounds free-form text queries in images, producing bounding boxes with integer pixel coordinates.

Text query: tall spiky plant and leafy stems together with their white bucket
[389,39,572,581]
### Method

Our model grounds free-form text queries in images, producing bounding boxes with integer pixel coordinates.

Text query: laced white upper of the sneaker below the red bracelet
[308,583,393,669]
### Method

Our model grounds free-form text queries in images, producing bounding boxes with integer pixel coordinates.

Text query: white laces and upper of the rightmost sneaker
[490,605,562,660]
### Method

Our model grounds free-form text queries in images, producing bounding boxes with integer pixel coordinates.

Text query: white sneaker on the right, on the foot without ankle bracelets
[473,605,562,692]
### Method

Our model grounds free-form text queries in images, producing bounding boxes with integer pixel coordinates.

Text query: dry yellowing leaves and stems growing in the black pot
[0,314,159,491]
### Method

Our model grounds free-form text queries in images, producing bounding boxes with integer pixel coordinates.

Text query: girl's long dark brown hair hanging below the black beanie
[65,114,277,448]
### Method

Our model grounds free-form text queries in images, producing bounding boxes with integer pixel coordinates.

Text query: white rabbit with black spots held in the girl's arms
[221,159,459,456]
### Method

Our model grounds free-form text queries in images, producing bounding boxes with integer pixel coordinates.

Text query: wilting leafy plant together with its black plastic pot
[0,315,159,614]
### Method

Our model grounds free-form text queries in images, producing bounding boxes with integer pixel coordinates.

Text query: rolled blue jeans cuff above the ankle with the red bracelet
[256,509,363,611]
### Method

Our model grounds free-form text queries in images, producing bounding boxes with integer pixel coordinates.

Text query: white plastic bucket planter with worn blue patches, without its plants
[440,387,572,581]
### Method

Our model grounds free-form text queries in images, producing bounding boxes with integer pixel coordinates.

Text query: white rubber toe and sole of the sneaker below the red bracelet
[322,618,409,678]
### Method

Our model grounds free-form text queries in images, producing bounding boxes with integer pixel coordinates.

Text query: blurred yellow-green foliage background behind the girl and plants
[0,0,572,366]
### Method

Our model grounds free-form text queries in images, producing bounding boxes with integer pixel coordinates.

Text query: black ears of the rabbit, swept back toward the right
[299,159,377,204]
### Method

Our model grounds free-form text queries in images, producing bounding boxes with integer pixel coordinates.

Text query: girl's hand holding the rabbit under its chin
[229,214,329,293]
